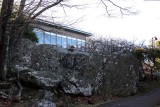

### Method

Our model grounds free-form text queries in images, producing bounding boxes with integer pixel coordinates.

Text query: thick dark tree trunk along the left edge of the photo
[0,0,14,80]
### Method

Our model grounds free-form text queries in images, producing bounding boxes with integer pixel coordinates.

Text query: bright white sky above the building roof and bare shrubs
[42,0,160,45]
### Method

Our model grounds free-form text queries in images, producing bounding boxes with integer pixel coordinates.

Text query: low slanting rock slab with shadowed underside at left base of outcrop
[19,69,63,90]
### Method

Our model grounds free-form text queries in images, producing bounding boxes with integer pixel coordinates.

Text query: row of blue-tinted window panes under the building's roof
[34,29,85,50]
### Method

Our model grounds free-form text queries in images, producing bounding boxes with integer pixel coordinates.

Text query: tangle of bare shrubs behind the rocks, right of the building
[87,38,136,55]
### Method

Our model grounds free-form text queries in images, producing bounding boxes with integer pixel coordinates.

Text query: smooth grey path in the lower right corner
[97,88,160,107]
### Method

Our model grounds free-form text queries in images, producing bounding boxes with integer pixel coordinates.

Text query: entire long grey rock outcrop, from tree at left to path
[11,40,143,96]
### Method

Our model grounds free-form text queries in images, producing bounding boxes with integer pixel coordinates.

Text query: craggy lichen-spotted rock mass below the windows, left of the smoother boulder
[11,42,94,96]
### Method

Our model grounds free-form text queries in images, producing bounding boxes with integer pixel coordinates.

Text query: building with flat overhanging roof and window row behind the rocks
[31,19,92,49]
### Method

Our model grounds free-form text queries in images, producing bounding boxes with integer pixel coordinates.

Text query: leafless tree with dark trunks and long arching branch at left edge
[0,0,70,80]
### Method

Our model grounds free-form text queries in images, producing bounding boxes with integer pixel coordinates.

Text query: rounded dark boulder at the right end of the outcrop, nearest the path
[102,52,141,96]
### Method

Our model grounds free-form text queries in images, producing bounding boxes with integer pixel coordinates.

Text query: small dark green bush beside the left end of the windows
[23,28,38,43]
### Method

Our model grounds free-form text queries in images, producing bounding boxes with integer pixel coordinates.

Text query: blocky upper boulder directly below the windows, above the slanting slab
[31,45,88,71]
